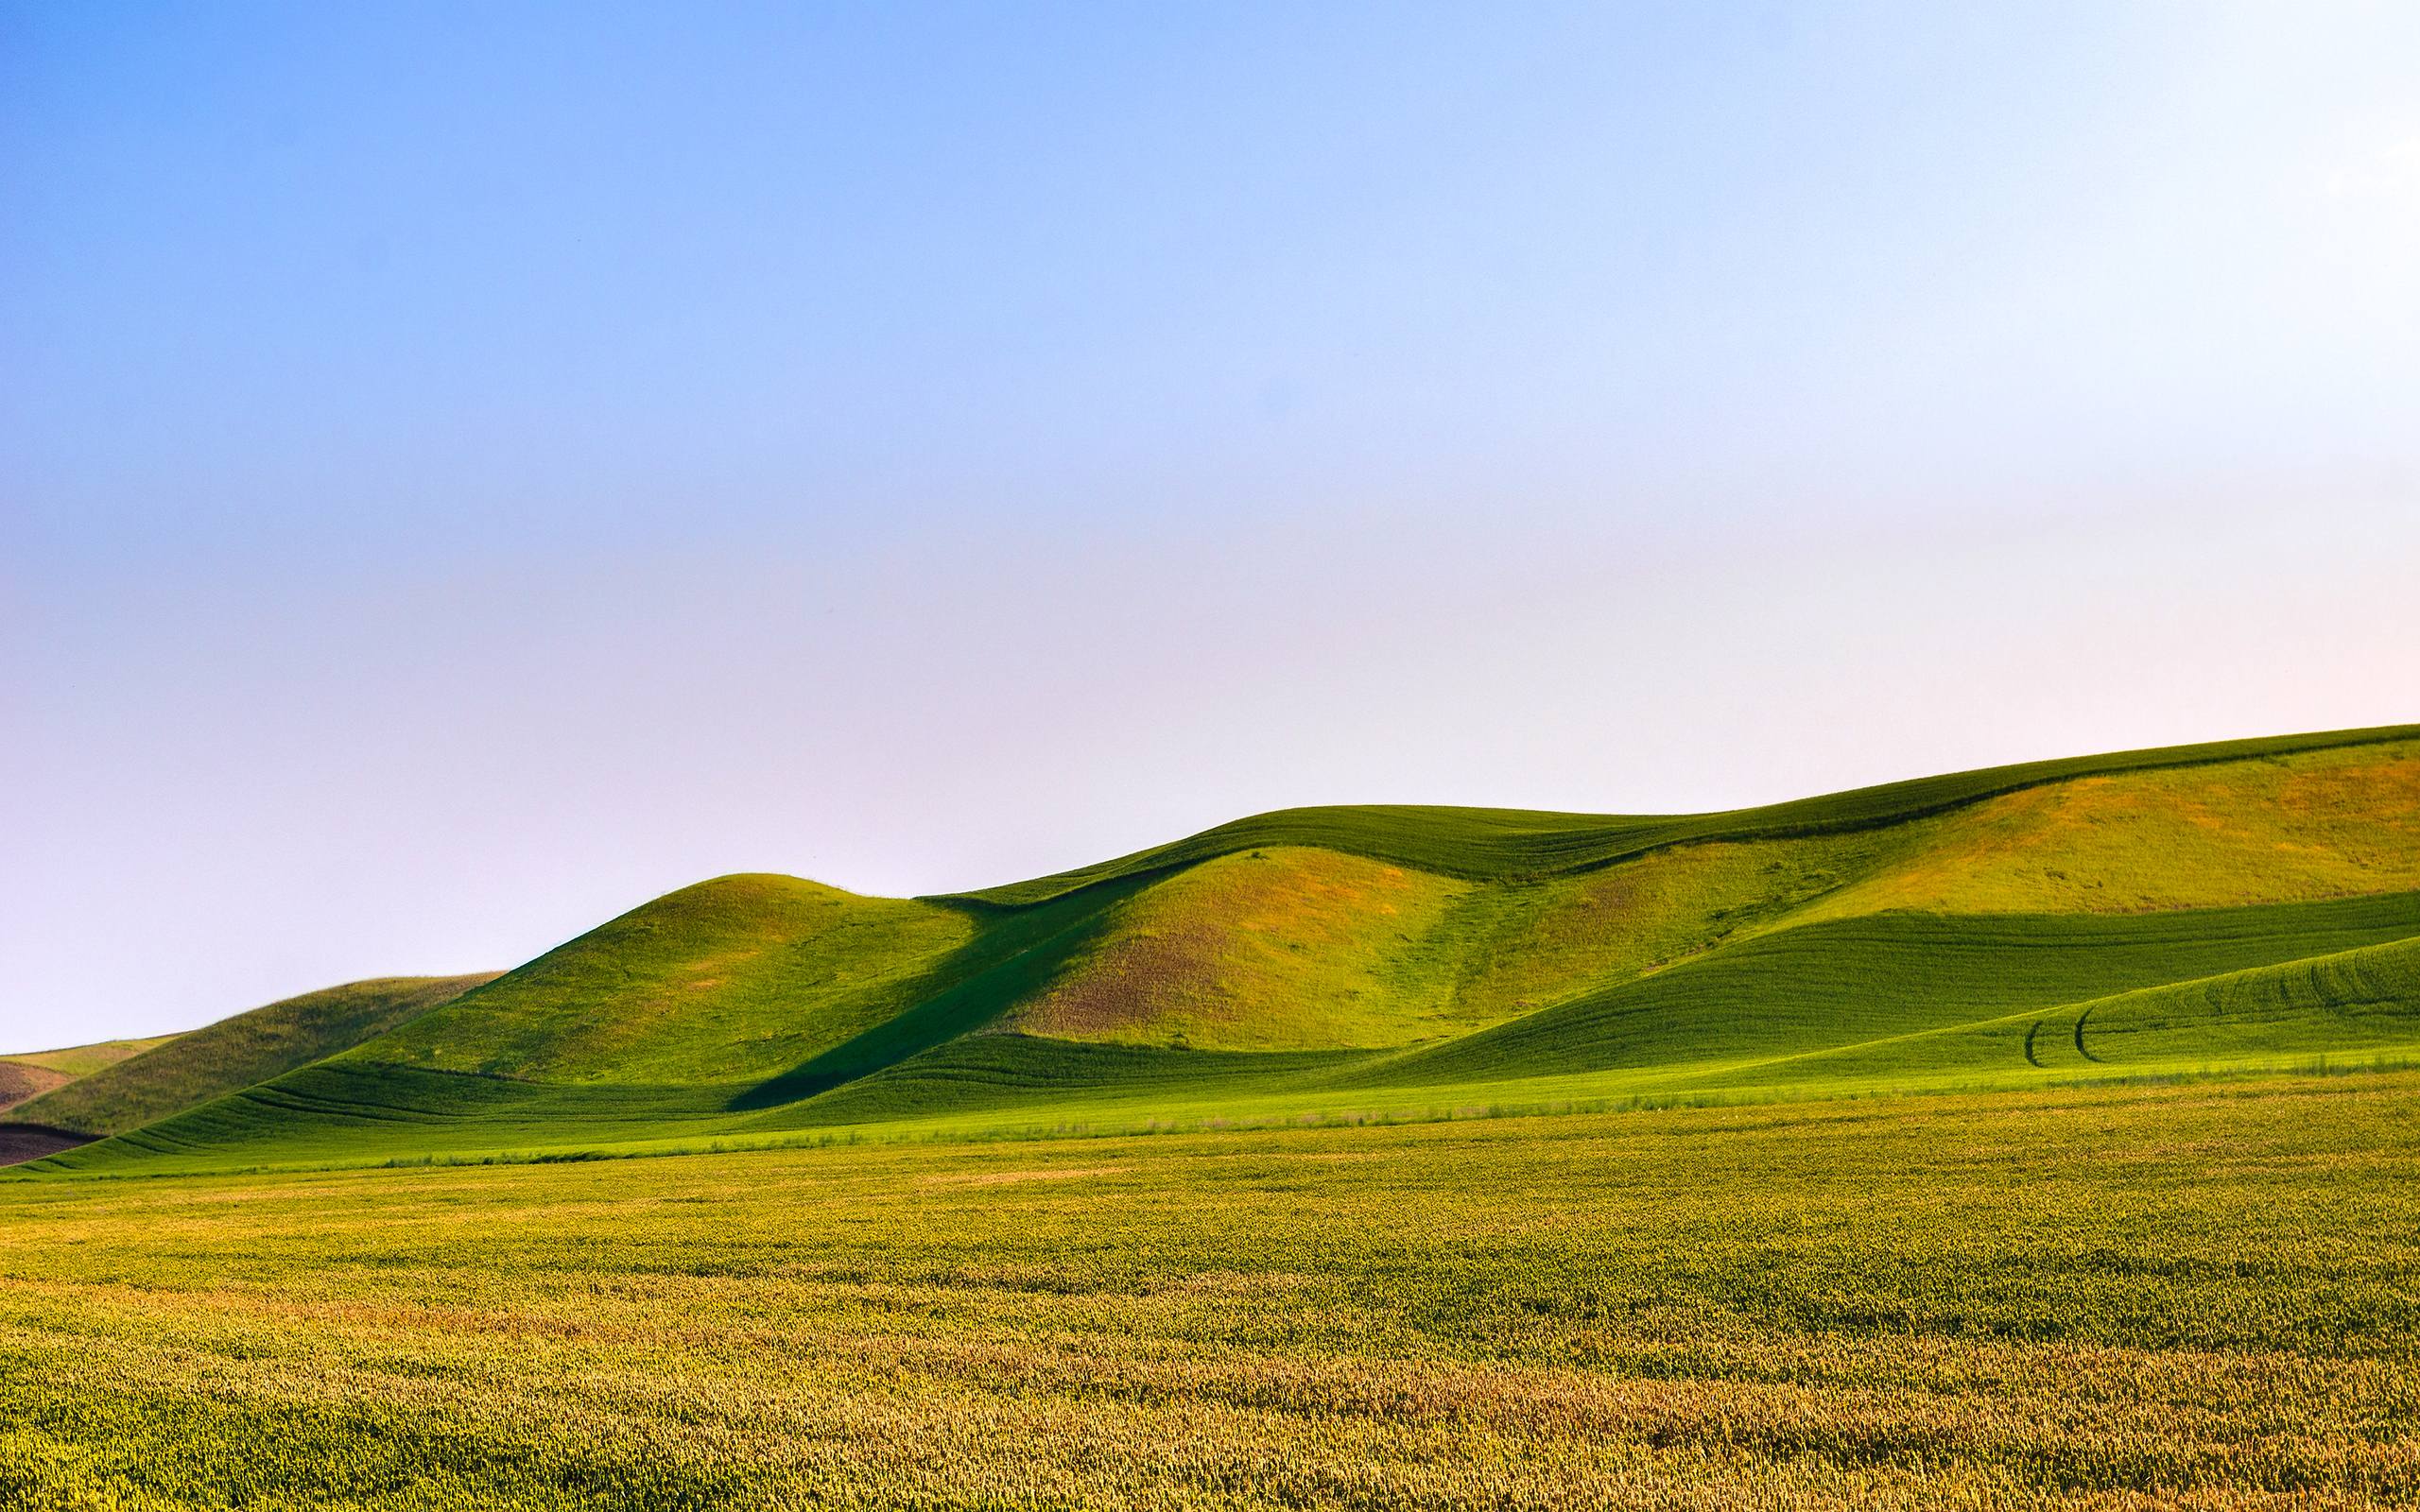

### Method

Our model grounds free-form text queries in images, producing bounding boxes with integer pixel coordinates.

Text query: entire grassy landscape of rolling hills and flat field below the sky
[0,729,2420,1512]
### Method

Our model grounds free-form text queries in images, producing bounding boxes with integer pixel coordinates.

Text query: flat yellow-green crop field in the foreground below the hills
[0,1072,2420,1509]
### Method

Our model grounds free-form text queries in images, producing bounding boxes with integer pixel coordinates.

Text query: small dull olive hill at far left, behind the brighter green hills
[9,975,489,1135]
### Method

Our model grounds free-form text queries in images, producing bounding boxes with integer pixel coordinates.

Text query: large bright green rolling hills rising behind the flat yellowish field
[23,729,2420,1171]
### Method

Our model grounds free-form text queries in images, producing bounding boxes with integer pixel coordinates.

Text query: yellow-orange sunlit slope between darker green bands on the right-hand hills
[987,740,2420,1062]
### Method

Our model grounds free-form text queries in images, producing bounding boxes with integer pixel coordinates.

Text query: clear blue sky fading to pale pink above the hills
[0,0,2420,1050]
